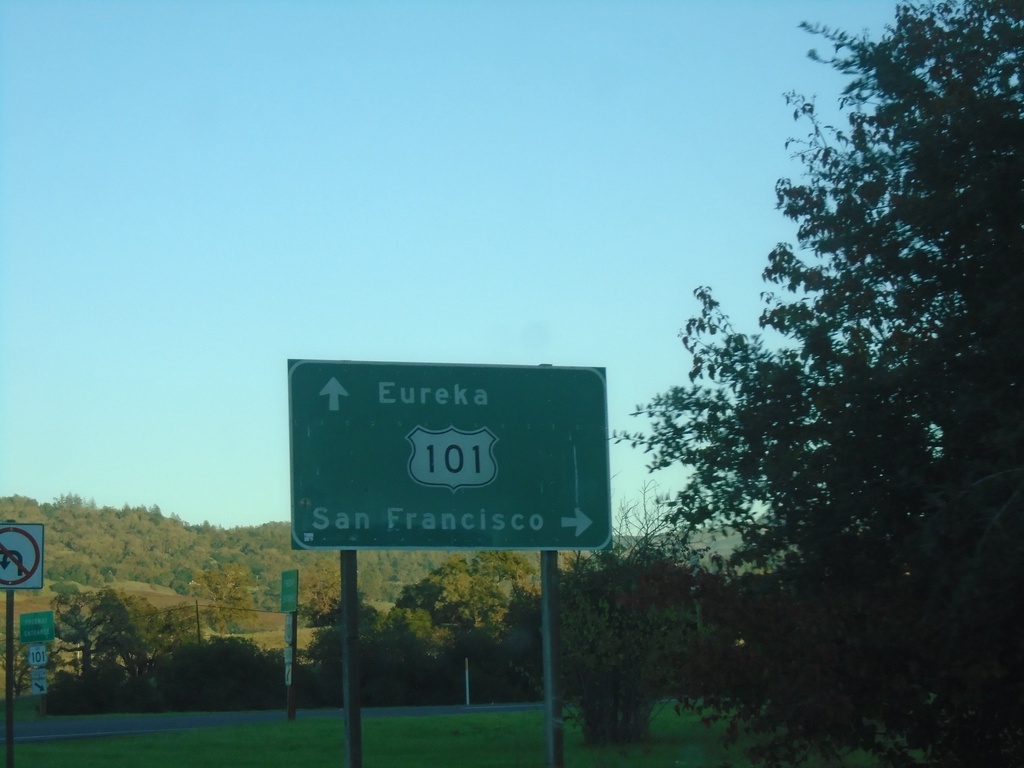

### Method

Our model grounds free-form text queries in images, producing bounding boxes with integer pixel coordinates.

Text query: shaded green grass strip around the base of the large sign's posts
[15,711,880,768]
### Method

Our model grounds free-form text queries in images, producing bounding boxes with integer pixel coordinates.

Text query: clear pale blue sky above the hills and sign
[0,0,894,526]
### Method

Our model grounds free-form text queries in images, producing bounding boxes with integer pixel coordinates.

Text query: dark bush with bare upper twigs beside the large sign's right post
[559,489,712,744]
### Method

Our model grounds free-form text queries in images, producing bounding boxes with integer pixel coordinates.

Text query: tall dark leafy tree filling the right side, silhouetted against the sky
[629,0,1024,766]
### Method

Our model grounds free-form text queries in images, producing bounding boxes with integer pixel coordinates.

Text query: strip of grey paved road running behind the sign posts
[0,703,543,743]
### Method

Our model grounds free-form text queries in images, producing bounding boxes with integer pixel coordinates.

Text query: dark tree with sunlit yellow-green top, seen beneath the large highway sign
[305,552,541,707]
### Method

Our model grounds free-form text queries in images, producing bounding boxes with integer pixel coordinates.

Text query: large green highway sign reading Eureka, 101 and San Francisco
[288,360,611,550]
